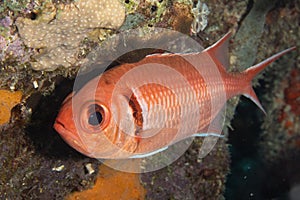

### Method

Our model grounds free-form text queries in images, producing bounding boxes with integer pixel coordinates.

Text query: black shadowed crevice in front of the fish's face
[26,79,83,159]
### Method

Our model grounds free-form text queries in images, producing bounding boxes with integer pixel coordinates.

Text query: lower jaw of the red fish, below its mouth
[53,120,89,156]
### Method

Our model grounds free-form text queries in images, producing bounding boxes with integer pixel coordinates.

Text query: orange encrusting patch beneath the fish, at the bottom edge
[66,165,146,200]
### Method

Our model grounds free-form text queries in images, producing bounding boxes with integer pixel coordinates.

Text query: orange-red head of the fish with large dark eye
[54,74,137,159]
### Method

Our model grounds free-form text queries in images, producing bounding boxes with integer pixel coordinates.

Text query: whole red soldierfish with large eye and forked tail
[54,33,294,159]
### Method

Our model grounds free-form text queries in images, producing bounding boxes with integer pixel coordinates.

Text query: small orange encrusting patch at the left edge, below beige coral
[0,90,22,125]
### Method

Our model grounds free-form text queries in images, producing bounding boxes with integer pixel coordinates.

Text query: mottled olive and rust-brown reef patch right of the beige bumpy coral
[121,0,194,34]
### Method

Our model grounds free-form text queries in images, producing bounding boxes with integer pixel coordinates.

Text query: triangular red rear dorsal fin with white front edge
[205,31,231,69]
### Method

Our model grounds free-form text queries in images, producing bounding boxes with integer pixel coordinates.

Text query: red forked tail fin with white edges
[243,47,296,113]
